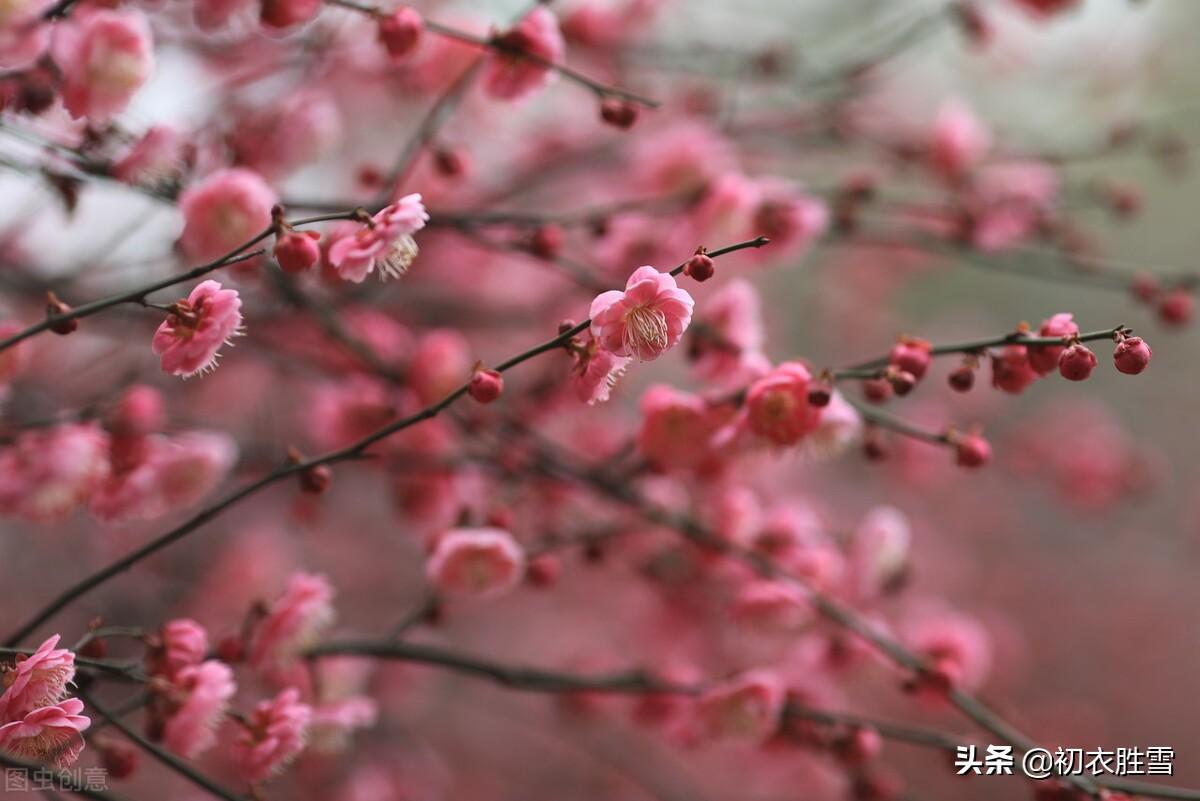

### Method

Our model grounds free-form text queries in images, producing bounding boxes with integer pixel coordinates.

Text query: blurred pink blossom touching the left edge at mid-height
[0,423,109,523]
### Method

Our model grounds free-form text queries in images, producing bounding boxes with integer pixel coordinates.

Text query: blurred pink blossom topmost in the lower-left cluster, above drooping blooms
[250,573,334,669]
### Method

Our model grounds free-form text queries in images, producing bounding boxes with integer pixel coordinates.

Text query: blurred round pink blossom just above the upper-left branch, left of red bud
[179,167,277,261]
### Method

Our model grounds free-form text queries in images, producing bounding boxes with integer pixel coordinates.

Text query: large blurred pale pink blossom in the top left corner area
[54,10,154,122]
